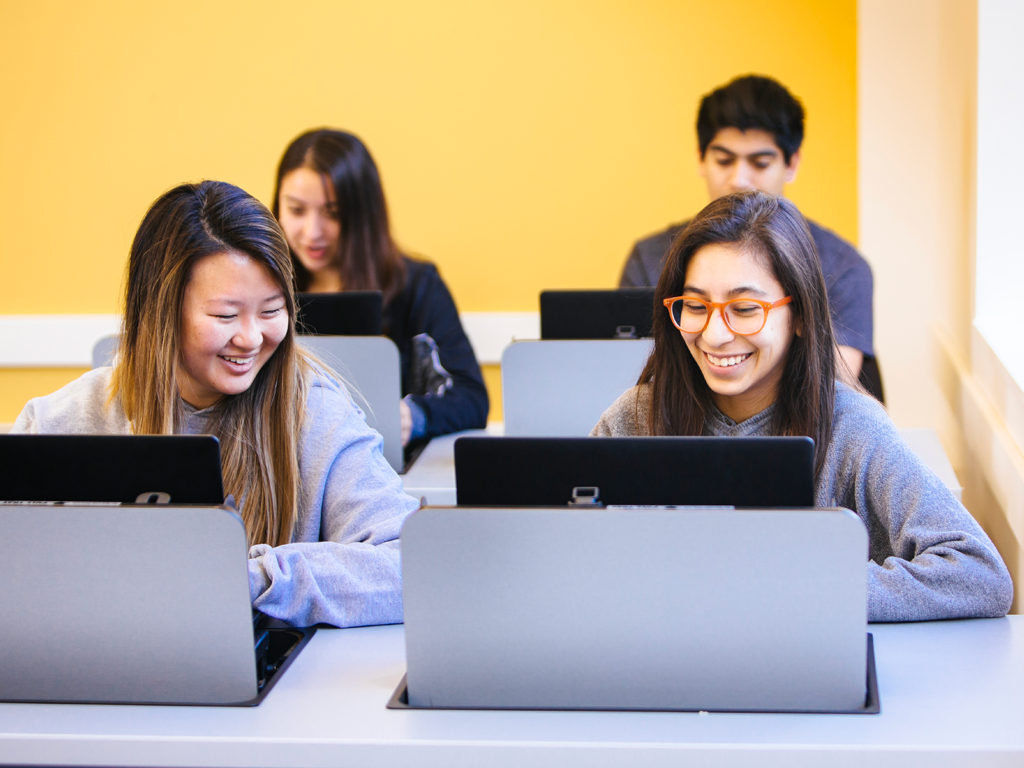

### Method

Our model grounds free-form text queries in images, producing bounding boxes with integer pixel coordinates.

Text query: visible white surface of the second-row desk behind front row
[402,422,962,505]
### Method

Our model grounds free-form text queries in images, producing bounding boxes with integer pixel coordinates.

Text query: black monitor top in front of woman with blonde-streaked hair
[0,434,224,505]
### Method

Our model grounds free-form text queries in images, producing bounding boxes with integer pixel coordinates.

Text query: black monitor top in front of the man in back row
[541,288,654,339]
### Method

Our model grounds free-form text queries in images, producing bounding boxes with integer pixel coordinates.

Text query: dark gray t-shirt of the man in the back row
[618,219,874,355]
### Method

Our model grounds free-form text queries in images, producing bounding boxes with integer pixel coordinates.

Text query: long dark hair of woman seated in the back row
[272,128,406,304]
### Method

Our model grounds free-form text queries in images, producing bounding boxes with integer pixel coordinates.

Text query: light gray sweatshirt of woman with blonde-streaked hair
[12,368,419,627]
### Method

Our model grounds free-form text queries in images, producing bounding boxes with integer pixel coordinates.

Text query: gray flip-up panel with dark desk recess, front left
[0,503,310,706]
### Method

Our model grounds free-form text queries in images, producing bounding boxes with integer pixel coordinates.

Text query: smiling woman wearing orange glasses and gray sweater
[593,191,1013,622]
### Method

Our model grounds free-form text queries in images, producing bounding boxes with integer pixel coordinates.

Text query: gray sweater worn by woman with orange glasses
[592,384,1013,622]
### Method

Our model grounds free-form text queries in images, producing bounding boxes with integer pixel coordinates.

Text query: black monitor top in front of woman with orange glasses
[455,437,814,507]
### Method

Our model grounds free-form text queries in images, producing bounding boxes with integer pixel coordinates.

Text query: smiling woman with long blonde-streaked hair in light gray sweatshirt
[13,181,418,627]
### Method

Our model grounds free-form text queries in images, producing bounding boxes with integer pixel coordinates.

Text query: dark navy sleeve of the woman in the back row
[409,264,489,437]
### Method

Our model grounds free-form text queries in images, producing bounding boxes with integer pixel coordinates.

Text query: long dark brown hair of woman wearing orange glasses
[637,190,837,475]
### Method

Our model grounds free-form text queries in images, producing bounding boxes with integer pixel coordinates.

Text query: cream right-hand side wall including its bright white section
[857,0,1024,612]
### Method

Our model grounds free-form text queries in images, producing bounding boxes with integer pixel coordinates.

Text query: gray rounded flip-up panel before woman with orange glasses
[391,507,878,712]
